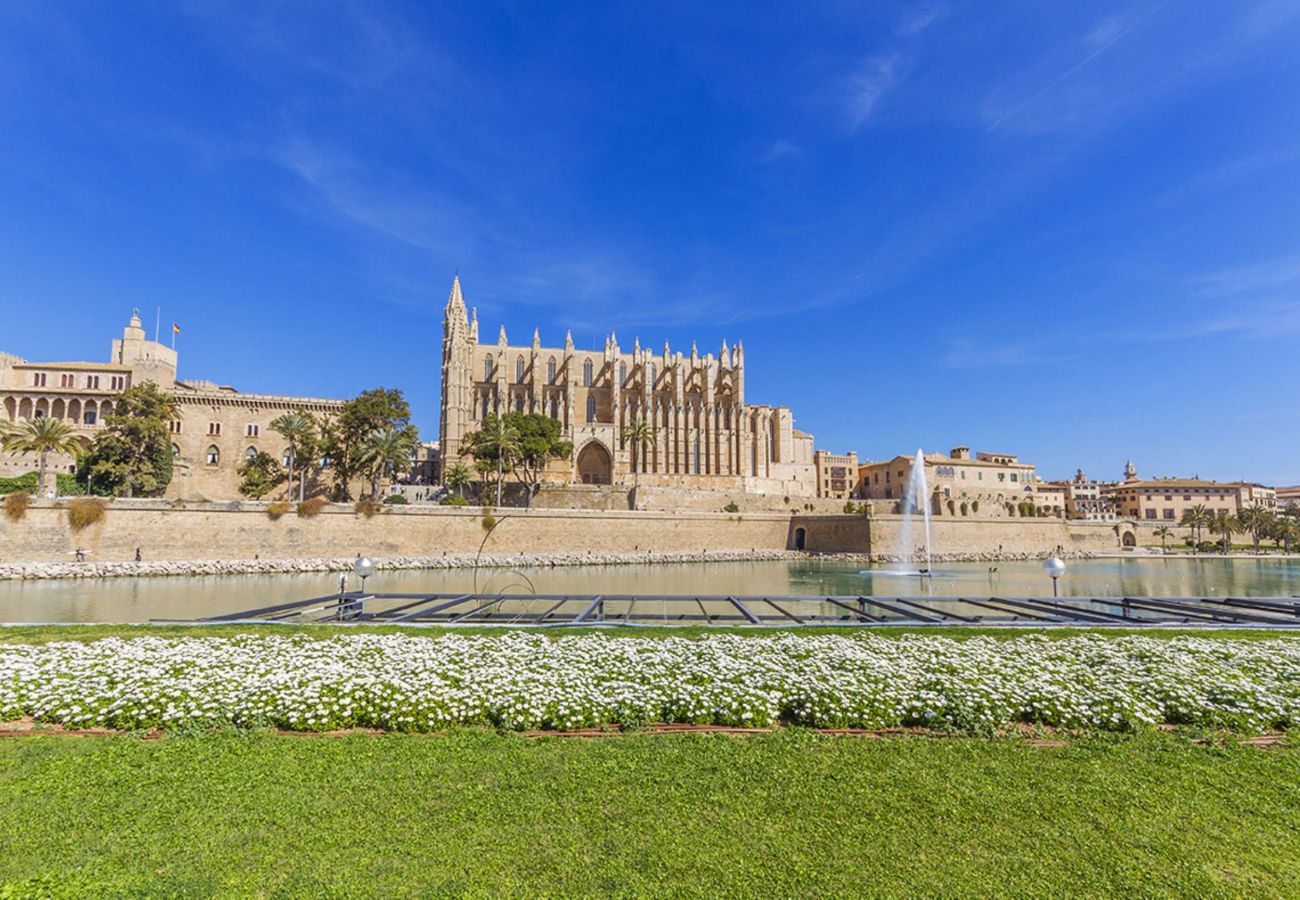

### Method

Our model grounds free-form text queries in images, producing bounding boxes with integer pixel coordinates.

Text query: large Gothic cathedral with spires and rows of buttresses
[439,277,816,497]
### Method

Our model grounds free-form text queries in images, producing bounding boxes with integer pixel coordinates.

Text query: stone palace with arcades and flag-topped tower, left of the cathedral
[0,310,343,491]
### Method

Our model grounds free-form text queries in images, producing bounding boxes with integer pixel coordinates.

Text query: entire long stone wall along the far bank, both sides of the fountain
[0,499,1160,563]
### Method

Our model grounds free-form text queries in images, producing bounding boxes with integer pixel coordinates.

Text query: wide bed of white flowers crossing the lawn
[0,633,1300,734]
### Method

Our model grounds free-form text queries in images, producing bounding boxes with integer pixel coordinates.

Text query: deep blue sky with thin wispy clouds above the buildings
[0,0,1300,483]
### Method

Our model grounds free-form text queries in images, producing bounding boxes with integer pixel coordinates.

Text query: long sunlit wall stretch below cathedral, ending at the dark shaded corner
[0,499,790,562]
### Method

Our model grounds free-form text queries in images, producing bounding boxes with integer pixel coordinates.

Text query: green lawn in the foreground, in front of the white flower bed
[0,731,1300,896]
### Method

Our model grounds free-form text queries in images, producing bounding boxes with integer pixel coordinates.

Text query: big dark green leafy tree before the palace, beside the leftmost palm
[77,381,181,497]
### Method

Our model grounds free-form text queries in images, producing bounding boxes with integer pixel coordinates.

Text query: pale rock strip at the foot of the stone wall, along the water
[0,550,1095,581]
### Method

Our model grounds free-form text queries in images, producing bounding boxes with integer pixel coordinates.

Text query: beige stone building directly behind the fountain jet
[857,447,1035,519]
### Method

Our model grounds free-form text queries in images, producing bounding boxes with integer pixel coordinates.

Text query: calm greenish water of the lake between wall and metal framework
[0,558,1300,622]
